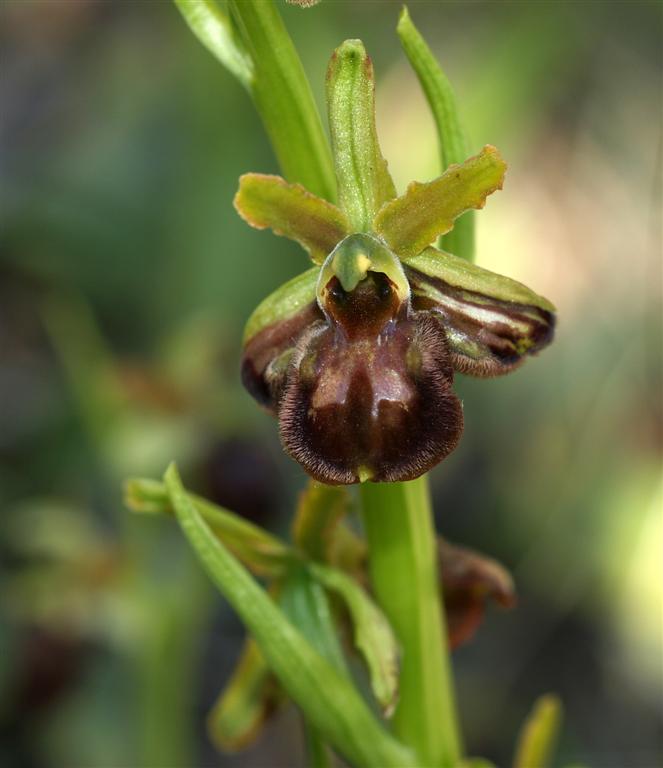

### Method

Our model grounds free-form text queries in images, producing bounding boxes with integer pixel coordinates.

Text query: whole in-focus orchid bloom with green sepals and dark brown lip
[235,39,554,484]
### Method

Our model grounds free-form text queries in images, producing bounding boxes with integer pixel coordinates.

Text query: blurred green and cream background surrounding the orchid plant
[0,0,663,768]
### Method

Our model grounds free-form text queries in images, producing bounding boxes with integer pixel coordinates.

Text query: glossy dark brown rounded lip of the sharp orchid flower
[279,272,463,484]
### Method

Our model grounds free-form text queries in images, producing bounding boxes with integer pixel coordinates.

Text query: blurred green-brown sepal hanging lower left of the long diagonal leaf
[207,639,282,752]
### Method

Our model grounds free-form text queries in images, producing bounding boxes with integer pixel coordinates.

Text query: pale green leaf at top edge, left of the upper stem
[175,0,254,91]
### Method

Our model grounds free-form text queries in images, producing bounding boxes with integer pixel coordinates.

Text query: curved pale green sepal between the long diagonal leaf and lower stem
[309,564,398,716]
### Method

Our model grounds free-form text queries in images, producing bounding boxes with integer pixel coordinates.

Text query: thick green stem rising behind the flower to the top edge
[228,0,336,202]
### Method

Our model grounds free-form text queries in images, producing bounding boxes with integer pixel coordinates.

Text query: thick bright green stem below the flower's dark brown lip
[361,476,461,768]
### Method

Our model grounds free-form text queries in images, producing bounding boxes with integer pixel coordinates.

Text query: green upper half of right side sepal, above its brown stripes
[404,247,556,312]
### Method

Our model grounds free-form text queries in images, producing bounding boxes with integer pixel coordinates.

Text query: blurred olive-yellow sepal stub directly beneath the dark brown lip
[292,480,350,562]
